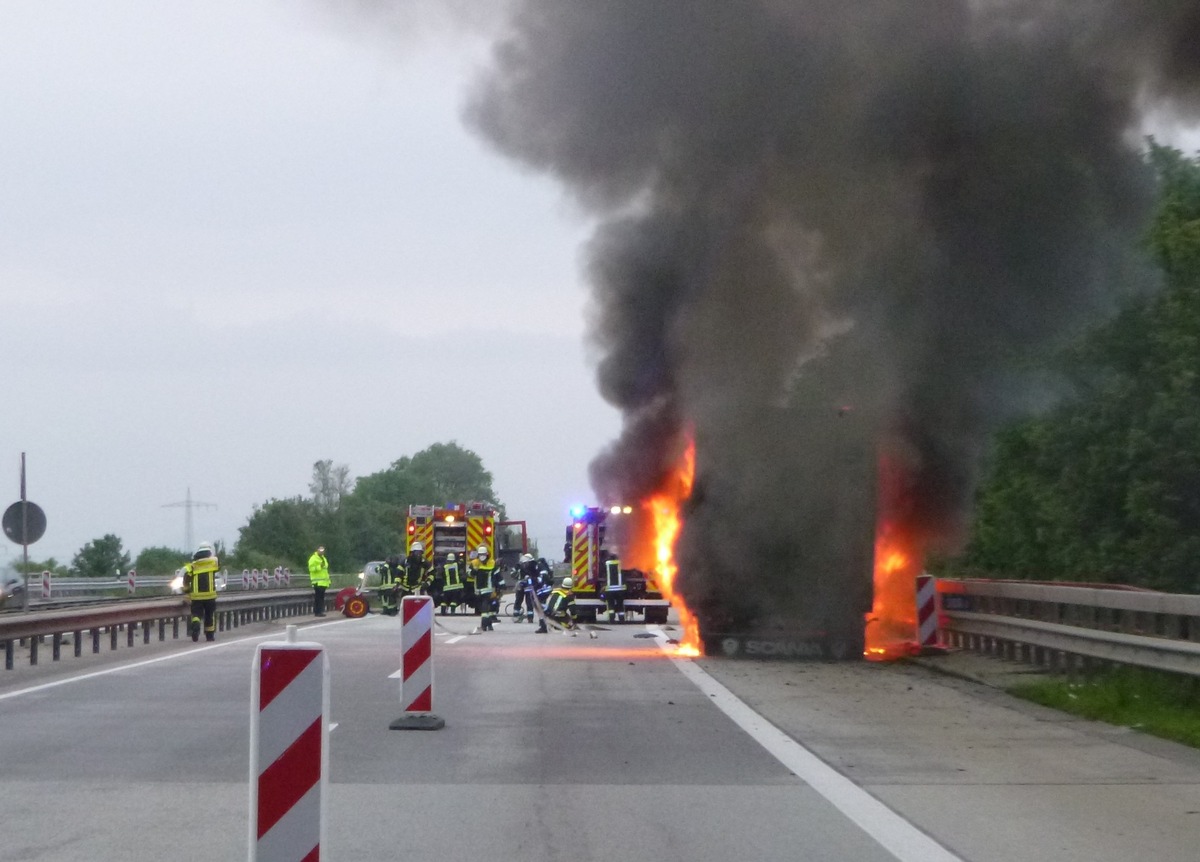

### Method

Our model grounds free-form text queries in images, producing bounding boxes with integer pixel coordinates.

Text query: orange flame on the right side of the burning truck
[864,460,924,662]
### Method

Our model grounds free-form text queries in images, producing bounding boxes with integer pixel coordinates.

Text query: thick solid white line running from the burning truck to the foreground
[647,627,962,862]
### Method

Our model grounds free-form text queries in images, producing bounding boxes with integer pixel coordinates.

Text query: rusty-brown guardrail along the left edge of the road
[0,589,334,670]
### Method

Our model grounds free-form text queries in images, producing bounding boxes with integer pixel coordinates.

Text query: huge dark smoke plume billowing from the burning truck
[468,0,1200,625]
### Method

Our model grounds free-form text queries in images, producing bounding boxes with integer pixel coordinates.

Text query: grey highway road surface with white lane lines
[0,616,1200,862]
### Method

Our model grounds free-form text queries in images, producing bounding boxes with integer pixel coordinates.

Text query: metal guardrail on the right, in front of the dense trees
[937,580,1200,676]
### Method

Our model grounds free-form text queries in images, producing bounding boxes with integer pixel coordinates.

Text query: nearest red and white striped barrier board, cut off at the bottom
[250,642,329,862]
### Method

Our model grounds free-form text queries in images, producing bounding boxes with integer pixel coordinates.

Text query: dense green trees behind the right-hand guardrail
[966,145,1200,592]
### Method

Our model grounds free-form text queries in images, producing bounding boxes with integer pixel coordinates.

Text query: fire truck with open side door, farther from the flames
[404,502,528,565]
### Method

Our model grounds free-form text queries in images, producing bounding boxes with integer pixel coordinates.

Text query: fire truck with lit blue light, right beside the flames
[563,505,671,624]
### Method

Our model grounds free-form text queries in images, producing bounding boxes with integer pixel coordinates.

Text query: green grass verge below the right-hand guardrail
[1008,668,1200,748]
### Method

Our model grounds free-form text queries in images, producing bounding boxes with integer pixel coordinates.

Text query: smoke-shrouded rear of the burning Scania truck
[678,405,877,659]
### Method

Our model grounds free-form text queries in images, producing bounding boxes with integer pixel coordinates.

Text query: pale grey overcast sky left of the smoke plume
[0,0,619,568]
